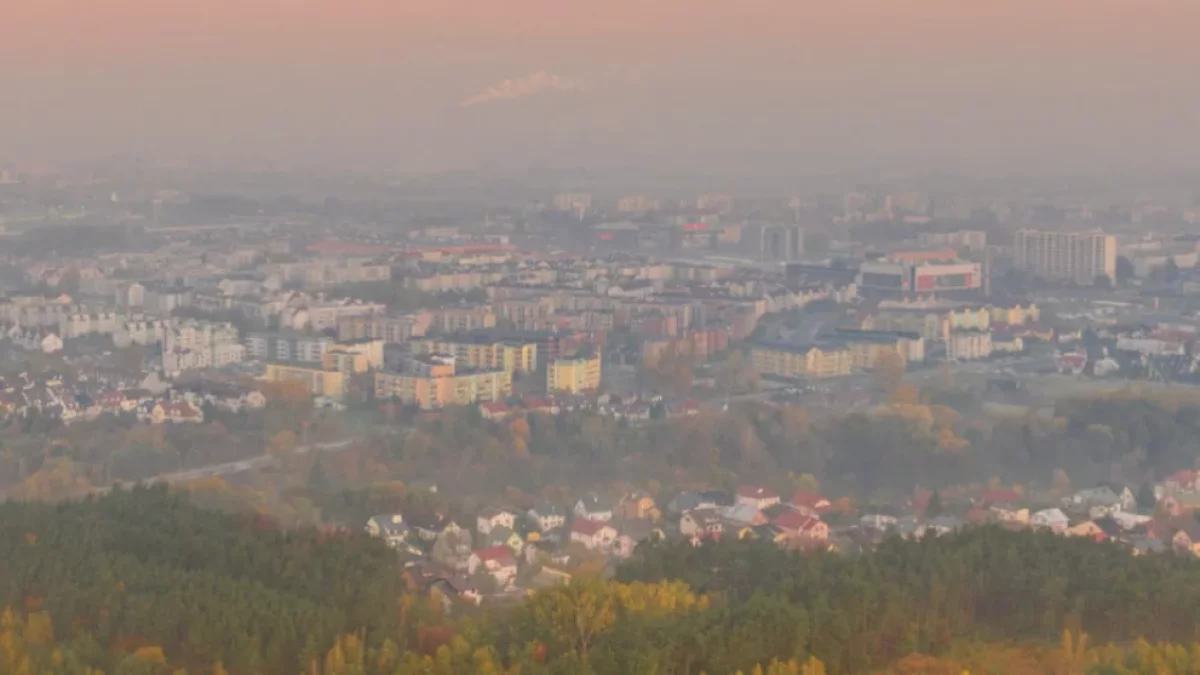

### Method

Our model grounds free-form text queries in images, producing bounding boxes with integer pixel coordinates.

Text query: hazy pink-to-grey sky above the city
[0,0,1200,171]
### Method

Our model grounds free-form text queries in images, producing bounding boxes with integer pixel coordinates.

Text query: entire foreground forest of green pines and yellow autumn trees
[9,489,1200,675]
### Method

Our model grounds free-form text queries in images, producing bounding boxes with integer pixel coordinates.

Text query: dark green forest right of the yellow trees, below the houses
[618,527,1200,673]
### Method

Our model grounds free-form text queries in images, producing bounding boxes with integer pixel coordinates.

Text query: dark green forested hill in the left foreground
[0,489,402,673]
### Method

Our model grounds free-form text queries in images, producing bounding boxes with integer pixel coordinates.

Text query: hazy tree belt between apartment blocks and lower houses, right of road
[360,388,1200,502]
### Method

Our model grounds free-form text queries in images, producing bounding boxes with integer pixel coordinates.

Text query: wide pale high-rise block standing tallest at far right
[1013,229,1117,285]
